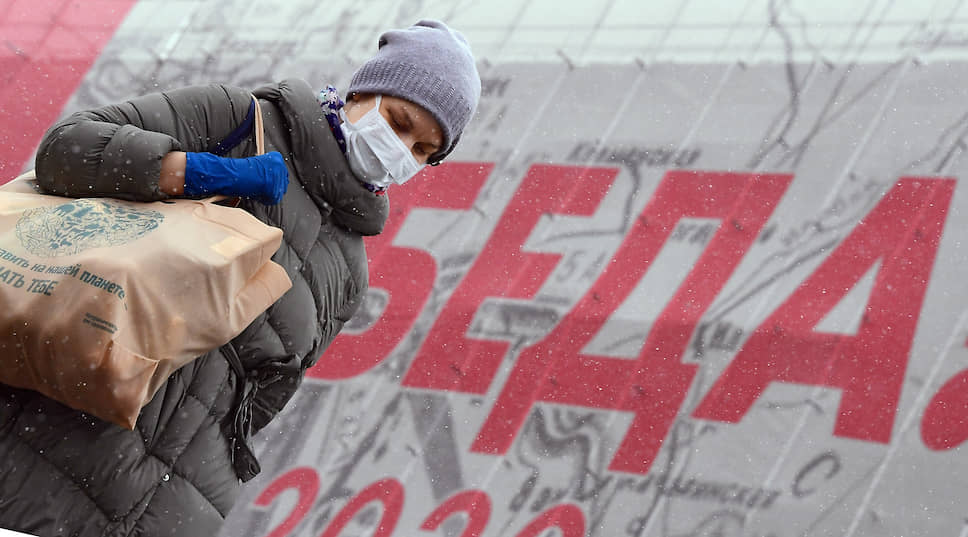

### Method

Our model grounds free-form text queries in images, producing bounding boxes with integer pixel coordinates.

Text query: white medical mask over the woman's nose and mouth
[339,95,424,188]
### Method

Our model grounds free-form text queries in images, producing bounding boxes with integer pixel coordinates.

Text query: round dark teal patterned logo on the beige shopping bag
[17,199,165,257]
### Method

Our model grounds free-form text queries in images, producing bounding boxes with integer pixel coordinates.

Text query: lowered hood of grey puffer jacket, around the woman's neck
[253,79,390,235]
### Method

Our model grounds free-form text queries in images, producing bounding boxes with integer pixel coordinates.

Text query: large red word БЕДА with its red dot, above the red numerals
[311,163,968,473]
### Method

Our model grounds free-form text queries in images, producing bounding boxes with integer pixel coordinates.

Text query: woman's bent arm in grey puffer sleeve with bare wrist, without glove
[36,85,254,201]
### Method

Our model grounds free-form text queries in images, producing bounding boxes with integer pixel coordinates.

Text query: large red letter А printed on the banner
[694,177,955,443]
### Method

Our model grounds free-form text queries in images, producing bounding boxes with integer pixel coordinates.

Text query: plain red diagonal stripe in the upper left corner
[0,0,137,180]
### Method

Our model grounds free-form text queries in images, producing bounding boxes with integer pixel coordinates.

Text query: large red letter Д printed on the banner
[470,171,791,473]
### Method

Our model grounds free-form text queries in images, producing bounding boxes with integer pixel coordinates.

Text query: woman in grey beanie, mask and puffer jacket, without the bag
[0,21,480,536]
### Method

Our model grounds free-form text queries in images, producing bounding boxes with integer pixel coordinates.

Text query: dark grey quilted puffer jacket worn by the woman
[0,80,388,536]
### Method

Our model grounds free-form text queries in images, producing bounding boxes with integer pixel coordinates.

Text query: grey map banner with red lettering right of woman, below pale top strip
[210,62,968,537]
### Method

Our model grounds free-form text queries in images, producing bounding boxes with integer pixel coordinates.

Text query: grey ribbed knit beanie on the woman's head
[348,20,481,164]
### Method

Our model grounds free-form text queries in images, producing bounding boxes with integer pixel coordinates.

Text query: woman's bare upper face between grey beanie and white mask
[343,94,443,164]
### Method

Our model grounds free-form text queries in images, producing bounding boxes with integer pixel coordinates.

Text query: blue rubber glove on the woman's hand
[185,151,289,205]
